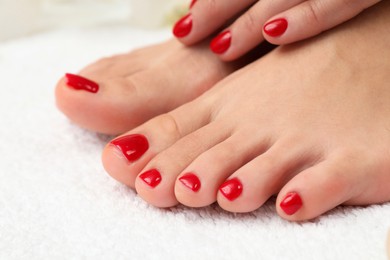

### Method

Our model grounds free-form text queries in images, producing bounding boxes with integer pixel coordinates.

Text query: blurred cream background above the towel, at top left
[0,0,190,41]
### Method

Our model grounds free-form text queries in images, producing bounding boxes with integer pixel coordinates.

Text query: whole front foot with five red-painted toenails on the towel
[102,2,390,221]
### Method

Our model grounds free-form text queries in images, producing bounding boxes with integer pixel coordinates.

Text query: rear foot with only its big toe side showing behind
[56,40,256,134]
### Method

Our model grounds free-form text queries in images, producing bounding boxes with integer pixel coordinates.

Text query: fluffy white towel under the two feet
[0,28,390,260]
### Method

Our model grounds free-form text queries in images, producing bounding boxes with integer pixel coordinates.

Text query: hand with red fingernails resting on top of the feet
[177,0,380,61]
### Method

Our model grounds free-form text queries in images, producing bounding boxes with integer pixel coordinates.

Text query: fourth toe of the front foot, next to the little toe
[218,139,317,212]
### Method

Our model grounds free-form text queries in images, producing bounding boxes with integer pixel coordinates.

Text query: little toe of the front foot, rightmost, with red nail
[276,154,371,221]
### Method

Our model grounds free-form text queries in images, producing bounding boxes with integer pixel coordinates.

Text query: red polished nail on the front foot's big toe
[111,134,149,162]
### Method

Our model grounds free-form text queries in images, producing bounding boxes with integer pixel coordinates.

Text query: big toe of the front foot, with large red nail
[102,96,212,188]
